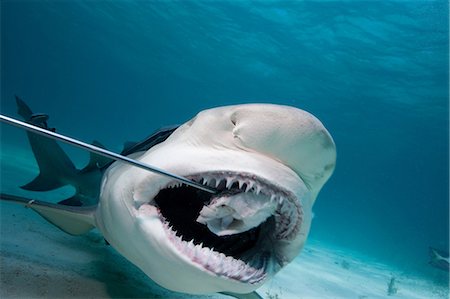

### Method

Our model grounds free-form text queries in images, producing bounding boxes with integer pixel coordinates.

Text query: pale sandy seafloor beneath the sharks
[0,145,449,299]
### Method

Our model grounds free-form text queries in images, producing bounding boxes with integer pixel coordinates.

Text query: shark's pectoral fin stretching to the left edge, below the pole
[0,193,96,235]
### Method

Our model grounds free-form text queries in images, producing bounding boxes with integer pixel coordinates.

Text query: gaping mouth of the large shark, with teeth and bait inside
[150,172,303,284]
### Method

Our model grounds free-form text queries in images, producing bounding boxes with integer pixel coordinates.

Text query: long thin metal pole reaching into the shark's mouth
[0,114,217,194]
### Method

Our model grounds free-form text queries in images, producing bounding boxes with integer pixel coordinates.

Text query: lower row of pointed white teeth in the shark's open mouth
[164,222,266,284]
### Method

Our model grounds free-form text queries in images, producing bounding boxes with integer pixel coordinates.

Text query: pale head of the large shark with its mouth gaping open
[97,104,336,294]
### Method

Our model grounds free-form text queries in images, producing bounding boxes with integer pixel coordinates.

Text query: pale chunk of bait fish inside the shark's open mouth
[197,193,276,236]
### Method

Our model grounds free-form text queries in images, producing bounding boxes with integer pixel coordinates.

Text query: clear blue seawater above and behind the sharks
[1,1,449,288]
